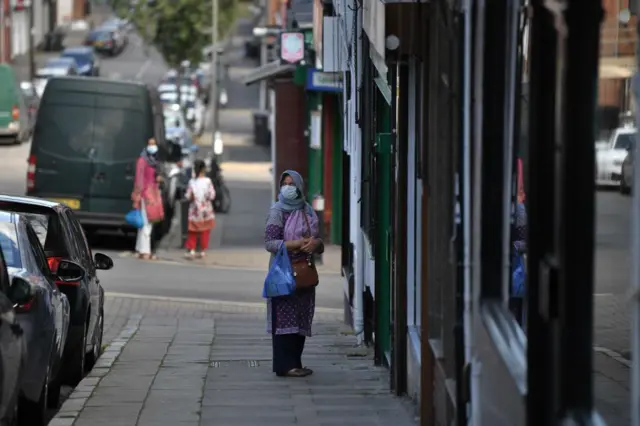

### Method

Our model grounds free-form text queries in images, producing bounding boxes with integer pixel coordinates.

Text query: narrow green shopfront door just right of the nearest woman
[375,91,392,365]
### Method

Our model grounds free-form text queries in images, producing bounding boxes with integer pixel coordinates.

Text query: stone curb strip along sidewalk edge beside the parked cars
[49,314,142,426]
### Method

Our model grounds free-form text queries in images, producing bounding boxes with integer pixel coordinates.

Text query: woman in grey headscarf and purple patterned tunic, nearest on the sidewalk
[264,170,324,377]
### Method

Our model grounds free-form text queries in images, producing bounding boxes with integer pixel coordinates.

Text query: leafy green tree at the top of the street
[124,0,238,67]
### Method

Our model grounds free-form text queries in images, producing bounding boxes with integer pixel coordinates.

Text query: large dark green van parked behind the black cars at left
[27,77,171,240]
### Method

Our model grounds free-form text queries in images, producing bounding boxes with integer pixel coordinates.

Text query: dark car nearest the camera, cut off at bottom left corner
[0,243,31,425]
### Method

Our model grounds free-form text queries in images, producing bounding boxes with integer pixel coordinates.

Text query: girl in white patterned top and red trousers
[184,160,216,259]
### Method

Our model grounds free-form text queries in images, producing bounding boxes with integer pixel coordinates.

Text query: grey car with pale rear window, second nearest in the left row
[0,212,70,426]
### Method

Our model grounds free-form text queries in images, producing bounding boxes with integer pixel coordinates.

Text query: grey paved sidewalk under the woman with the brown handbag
[50,314,416,426]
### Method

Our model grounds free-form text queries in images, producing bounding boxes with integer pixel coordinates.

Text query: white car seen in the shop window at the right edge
[595,127,637,186]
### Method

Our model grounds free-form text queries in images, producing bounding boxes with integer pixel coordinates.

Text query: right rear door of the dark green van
[90,96,148,216]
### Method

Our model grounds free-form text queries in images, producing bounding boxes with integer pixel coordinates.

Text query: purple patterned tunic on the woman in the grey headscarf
[264,208,322,337]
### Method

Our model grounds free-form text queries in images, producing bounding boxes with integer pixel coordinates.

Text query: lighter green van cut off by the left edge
[0,64,30,143]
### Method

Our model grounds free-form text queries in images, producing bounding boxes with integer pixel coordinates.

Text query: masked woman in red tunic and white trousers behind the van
[131,138,164,260]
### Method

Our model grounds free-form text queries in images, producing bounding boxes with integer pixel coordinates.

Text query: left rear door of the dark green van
[29,86,95,203]
